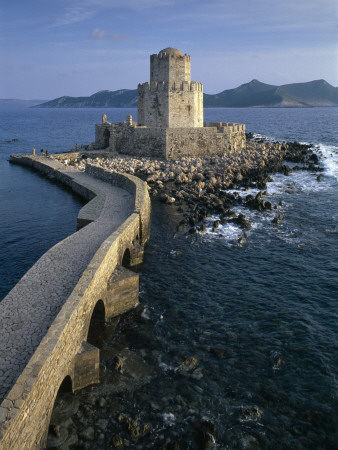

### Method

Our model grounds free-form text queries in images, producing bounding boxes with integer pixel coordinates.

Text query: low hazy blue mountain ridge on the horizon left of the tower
[36,89,137,108]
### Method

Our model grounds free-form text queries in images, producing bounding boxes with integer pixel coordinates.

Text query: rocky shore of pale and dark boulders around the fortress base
[65,140,323,241]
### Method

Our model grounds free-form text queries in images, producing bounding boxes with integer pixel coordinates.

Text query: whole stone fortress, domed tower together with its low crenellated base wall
[94,47,246,159]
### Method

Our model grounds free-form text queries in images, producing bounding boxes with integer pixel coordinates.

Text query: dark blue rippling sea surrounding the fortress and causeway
[0,108,338,449]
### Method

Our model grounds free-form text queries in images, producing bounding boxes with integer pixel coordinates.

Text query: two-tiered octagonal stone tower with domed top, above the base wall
[138,47,203,128]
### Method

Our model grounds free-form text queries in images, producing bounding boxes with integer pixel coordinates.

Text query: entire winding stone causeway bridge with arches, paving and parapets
[0,155,150,450]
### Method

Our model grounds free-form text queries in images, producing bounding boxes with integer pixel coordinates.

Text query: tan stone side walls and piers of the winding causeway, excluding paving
[0,156,150,450]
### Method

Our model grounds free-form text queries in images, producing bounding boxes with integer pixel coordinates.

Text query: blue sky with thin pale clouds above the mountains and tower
[0,0,338,100]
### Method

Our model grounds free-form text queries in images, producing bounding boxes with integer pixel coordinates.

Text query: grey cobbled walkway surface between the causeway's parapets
[0,169,134,403]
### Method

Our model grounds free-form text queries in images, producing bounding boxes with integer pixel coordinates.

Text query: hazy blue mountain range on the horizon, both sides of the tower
[35,80,338,108]
